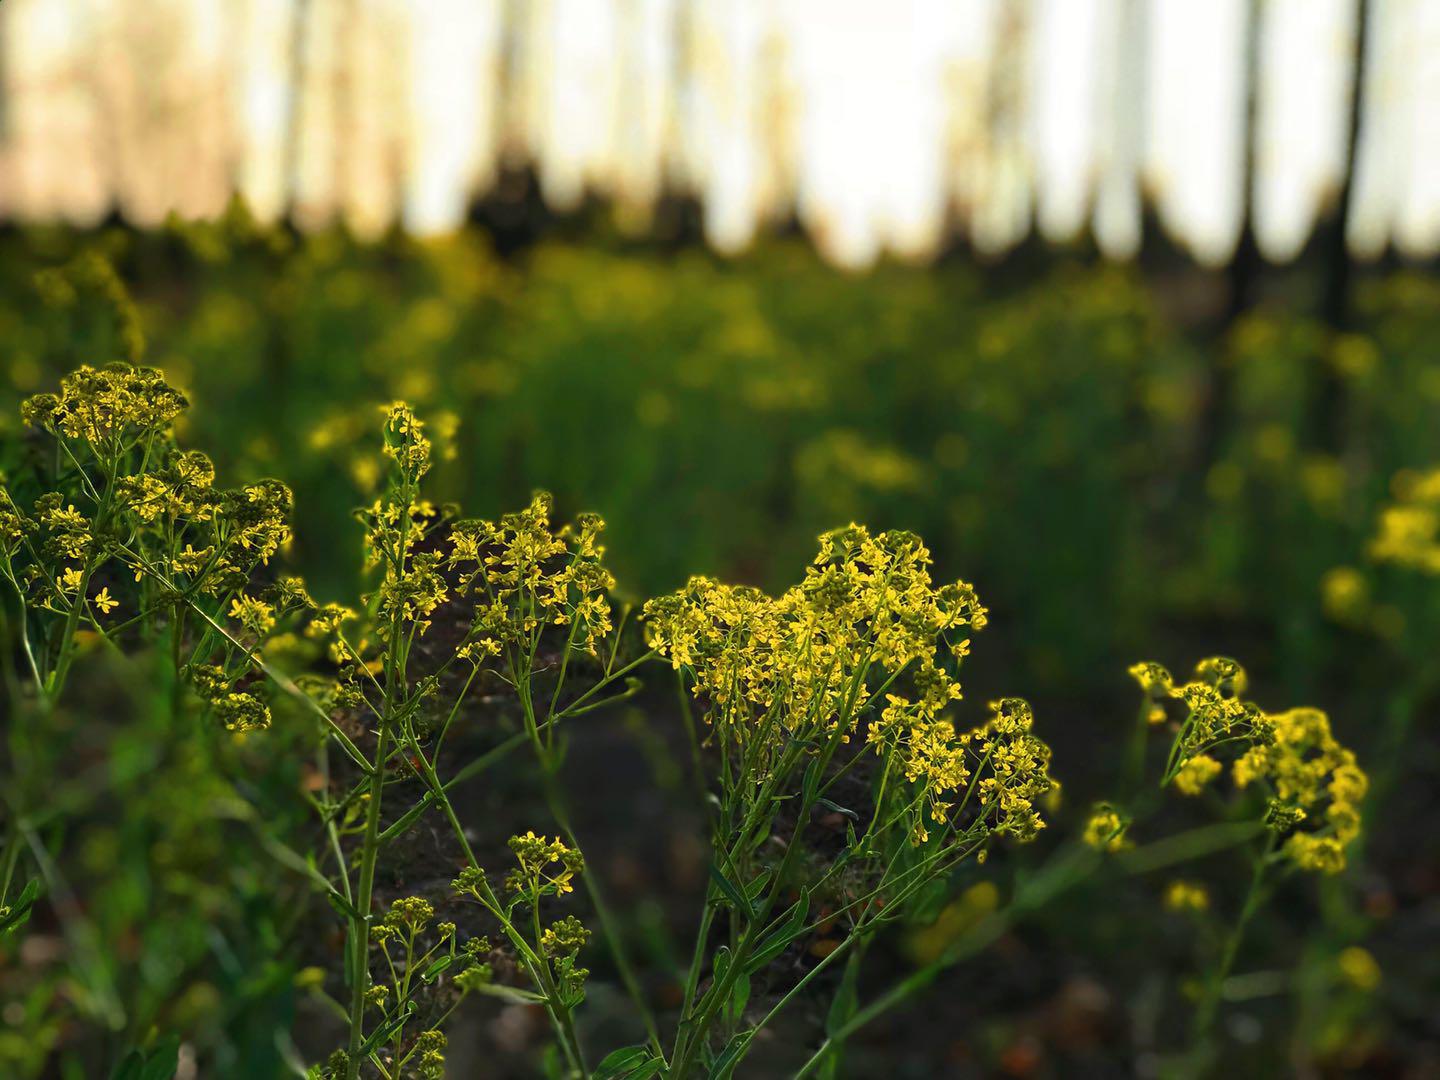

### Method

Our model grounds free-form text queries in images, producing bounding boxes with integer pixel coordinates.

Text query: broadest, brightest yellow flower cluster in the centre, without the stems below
[645,524,1050,842]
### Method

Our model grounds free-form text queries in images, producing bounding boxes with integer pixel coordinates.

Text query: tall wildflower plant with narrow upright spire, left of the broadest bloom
[283,403,639,1079]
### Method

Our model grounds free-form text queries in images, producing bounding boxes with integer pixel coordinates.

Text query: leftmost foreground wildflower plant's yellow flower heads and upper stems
[0,363,295,714]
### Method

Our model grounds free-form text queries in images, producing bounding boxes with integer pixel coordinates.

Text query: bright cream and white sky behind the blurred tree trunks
[0,0,1440,266]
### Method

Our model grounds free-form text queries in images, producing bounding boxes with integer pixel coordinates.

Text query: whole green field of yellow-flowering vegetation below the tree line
[0,215,1440,1077]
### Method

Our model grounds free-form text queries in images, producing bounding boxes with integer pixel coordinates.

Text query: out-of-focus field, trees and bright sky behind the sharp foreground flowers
[0,0,1440,1077]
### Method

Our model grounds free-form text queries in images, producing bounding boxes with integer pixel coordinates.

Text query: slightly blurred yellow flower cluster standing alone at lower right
[1130,657,1368,873]
